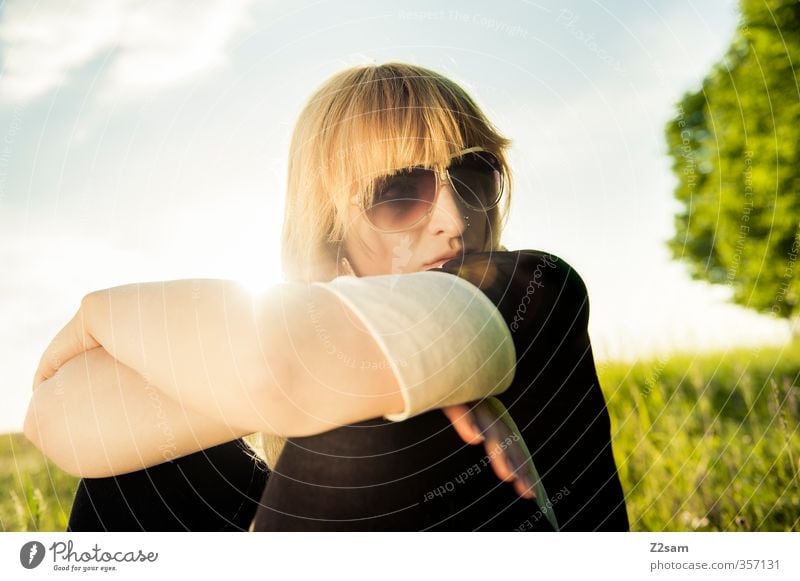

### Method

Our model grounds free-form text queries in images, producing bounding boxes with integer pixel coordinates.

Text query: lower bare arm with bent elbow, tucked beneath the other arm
[24,348,255,478]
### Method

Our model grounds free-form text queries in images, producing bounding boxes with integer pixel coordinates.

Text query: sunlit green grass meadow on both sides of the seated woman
[0,342,800,531]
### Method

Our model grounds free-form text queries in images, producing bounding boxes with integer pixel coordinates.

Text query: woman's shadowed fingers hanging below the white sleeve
[442,397,538,498]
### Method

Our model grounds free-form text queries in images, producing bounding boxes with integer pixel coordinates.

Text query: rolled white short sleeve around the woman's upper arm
[312,270,516,421]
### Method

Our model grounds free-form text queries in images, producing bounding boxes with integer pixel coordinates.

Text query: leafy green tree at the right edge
[666,0,800,334]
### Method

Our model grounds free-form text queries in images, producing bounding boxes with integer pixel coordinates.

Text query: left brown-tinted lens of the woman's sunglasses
[367,168,436,231]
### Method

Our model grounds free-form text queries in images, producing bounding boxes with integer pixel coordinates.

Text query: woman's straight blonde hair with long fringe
[282,63,511,282]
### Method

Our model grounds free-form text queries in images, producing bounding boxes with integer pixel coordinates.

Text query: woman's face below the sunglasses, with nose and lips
[344,178,490,276]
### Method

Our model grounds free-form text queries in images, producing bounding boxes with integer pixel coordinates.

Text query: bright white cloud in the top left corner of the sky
[0,0,252,102]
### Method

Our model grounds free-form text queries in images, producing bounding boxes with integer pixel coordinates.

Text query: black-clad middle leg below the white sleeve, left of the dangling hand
[254,410,558,531]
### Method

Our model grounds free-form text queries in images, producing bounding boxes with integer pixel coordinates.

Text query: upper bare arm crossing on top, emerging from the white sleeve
[37,279,403,436]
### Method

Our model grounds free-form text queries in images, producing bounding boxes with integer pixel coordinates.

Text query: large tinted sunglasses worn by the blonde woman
[353,147,504,233]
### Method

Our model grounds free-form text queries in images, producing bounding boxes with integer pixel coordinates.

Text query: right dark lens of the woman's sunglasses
[448,151,503,210]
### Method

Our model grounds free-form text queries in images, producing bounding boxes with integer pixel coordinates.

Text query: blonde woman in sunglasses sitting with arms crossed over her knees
[25,63,628,530]
